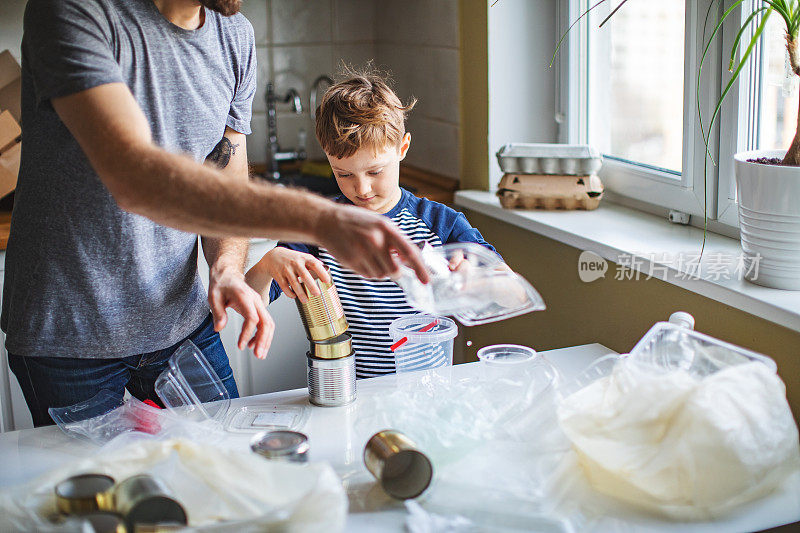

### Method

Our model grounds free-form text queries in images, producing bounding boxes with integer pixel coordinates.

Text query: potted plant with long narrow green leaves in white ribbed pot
[554,0,800,290]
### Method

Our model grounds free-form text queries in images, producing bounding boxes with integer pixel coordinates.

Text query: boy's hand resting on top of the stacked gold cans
[264,246,331,303]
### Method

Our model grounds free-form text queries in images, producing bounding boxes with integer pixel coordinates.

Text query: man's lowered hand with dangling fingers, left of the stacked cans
[208,267,275,359]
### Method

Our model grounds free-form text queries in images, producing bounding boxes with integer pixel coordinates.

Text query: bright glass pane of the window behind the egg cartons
[588,0,685,175]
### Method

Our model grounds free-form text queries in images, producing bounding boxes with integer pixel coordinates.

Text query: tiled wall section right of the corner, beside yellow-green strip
[375,0,461,178]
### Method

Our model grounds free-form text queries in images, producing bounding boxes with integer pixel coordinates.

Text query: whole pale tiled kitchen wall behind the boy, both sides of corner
[242,0,460,177]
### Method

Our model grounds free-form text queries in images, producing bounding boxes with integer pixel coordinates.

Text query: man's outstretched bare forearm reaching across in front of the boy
[116,145,335,242]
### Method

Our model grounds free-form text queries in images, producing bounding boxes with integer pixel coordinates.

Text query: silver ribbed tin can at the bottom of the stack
[307,353,356,407]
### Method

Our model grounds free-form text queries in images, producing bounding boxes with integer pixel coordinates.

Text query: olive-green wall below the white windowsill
[458,211,800,419]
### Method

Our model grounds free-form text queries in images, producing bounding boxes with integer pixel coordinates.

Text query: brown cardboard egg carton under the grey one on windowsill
[497,174,603,211]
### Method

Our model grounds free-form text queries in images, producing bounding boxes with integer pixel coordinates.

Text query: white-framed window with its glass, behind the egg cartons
[558,0,727,218]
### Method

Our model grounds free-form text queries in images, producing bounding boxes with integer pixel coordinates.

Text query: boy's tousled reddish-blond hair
[315,66,417,159]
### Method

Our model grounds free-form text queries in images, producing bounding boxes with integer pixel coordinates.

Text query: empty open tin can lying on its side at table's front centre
[364,429,433,500]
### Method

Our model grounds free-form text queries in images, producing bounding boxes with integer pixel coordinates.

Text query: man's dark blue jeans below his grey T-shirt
[8,314,239,427]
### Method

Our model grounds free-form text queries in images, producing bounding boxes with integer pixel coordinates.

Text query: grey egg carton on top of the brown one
[497,143,603,176]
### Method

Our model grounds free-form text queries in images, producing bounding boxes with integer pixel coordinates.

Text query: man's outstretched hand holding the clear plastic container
[317,205,430,283]
